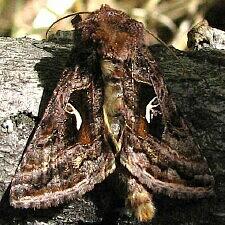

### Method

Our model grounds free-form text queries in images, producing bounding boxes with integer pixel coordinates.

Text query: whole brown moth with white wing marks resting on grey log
[10,5,214,221]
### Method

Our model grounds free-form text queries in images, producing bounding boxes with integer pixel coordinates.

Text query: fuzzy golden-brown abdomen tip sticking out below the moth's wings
[126,178,155,222]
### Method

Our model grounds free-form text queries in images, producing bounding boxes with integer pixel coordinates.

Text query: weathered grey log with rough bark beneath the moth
[0,35,225,225]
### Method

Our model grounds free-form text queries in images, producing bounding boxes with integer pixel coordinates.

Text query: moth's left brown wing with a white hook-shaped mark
[10,67,114,208]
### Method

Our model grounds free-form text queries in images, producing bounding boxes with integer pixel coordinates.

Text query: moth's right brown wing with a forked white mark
[120,49,214,198]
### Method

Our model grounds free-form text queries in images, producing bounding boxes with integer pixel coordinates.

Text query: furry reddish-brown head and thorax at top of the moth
[75,5,144,61]
